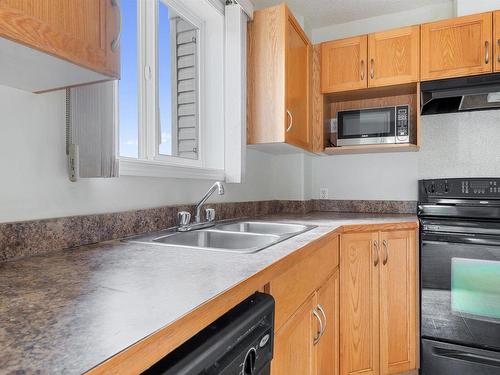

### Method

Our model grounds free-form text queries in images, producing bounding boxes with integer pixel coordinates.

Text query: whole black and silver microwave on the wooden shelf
[332,105,410,146]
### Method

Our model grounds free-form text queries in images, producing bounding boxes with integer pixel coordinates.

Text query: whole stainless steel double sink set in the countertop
[126,220,315,253]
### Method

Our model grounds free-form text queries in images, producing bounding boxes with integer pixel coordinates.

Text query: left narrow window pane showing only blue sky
[118,0,139,158]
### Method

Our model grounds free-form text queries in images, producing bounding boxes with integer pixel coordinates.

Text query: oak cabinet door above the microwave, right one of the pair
[368,25,420,87]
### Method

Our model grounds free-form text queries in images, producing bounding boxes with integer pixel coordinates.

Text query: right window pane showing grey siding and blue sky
[157,1,199,159]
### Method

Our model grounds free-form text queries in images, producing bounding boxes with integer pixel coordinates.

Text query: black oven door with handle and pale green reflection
[420,220,500,350]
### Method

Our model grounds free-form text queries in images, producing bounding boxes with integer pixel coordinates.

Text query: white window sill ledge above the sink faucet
[120,157,225,180]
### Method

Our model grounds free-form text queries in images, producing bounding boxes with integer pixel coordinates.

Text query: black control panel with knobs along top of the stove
[419,178,500,200]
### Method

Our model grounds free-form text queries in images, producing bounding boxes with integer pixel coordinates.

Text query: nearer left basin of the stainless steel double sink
[153,230,279,252]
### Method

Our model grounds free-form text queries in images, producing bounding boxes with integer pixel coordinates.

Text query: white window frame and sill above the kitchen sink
[120,0,225,179]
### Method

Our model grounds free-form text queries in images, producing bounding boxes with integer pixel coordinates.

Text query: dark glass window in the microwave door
[338,107,395,138]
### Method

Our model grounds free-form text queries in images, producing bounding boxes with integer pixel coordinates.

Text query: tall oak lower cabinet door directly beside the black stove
[380,230,417,374]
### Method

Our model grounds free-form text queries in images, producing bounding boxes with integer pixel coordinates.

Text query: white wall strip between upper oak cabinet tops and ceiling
[312,0,454,43]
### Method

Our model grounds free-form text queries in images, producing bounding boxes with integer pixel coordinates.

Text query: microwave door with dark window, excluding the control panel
[337,107,396,146]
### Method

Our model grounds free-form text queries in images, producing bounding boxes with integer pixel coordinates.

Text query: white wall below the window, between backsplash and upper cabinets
[0,86,304,222]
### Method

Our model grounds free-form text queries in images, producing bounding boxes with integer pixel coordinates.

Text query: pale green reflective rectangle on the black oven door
[451,258,500,320]
